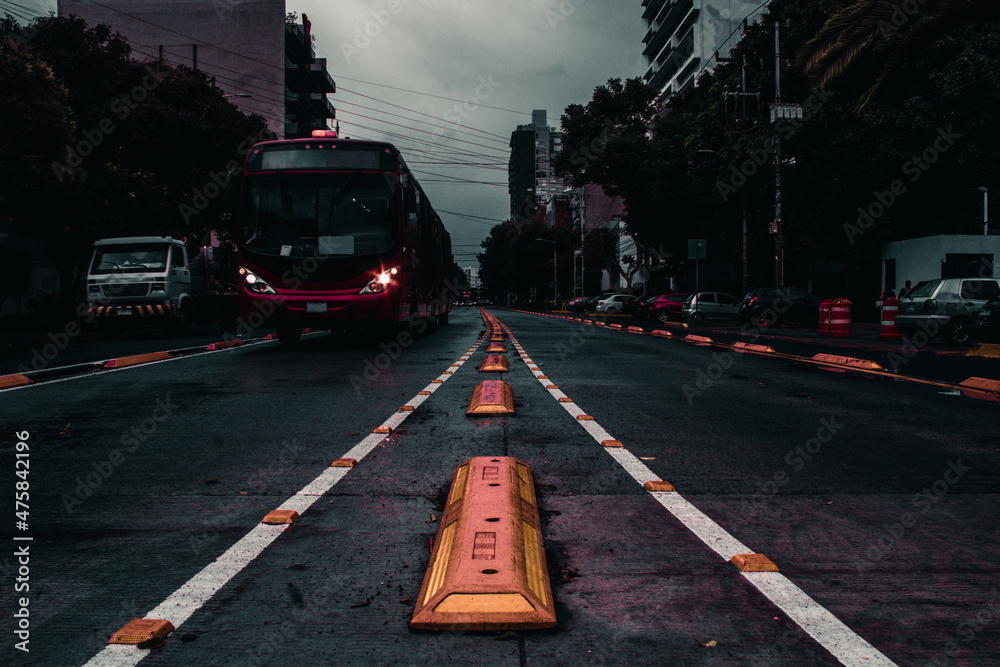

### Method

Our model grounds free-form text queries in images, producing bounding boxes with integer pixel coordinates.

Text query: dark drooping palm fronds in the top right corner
[796,0,1000,110]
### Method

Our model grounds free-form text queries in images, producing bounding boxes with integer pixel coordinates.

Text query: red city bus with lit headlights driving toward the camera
[233,131,453,344]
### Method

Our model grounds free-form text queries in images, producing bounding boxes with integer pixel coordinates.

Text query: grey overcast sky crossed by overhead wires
[25,0,645,266]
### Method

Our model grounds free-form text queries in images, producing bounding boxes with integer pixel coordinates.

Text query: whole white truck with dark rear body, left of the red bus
[87,236,238,338]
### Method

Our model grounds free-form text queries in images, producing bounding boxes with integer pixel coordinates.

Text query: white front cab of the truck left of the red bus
[87,236,192,338]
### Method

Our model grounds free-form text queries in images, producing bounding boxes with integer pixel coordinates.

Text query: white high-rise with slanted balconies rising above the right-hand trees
[642,0,764,103]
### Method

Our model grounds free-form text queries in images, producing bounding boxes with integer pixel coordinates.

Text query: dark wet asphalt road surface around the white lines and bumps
[0,309,1000,665]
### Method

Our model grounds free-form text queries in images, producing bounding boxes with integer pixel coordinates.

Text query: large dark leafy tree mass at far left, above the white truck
[0,17,273,318]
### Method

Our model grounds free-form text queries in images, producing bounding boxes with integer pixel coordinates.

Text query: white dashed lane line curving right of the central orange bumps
[504,314,895,667]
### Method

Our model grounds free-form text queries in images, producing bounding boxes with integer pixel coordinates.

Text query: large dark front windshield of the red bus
[242,171,398,257]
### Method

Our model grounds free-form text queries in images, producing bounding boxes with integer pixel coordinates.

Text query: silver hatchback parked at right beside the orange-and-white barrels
[896,278,1000,345]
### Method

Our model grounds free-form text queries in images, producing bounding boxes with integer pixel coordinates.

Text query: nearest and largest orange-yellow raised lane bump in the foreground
[410,456,556,630]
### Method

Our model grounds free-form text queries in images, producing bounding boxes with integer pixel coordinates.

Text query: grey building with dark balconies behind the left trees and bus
[58,0,336,138]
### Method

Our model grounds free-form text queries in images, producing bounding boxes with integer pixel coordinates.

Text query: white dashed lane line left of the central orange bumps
[85,335,486,667]
